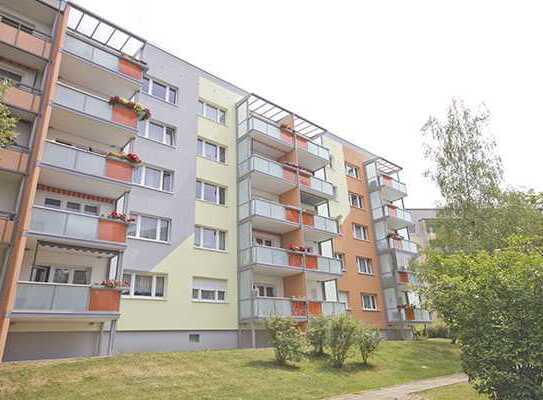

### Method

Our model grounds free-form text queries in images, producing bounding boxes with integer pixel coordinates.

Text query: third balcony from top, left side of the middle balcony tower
[239,199,300,234]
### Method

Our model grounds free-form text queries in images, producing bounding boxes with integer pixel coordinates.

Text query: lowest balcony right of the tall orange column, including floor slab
[12,282,121,321]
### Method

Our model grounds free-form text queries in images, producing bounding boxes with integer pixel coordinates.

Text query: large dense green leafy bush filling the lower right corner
[419,242,543,400]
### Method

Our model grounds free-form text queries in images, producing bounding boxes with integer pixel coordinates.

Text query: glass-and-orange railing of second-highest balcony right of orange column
[55,84,137,129]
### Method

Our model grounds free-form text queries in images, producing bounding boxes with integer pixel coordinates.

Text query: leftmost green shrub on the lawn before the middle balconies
[266,316,304,365]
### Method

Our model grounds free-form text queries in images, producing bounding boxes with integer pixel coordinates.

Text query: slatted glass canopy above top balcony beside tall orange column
[68,3,146,59]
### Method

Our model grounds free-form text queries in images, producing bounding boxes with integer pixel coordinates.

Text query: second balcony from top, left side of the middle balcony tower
[238,156,297,194]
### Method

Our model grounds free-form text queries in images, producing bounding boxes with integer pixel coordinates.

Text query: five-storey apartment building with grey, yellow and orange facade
[0,0,429,361]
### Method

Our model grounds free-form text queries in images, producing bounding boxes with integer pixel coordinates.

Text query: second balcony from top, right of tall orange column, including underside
[51,83,138,148]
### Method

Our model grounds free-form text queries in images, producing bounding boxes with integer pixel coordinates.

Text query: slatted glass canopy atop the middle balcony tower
[243,94,327,138]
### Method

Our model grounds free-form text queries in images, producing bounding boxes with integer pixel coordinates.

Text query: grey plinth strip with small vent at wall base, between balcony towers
[115,331,238,353]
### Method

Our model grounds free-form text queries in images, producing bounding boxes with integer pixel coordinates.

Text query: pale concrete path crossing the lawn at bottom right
[329,374,468,400]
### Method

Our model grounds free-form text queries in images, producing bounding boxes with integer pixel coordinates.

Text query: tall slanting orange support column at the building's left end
[0,5,70,362]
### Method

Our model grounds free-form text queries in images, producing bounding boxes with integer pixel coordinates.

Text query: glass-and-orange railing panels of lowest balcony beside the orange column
[14,282,120,313]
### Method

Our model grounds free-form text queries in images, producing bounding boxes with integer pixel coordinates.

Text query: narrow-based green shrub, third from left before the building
[327,315,360,368]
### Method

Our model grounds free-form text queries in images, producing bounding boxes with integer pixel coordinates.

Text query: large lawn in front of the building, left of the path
[0,340,461,400]
